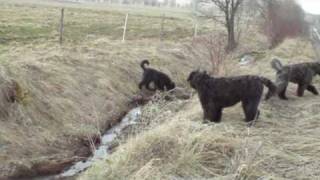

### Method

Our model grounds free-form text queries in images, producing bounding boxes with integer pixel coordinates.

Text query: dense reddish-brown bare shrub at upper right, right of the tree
[262,0,308,48]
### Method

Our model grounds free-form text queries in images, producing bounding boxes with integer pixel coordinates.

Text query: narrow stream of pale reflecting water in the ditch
[54,107,141,179]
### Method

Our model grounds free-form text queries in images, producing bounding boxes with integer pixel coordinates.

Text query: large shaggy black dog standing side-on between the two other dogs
[188,71,276,122]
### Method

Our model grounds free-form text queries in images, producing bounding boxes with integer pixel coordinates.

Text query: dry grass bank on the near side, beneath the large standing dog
[79,34,320,180]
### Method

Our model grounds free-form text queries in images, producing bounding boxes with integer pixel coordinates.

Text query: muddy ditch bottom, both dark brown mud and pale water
[7,106,133,180]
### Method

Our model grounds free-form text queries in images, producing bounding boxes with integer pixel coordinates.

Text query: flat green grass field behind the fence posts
[0,1,214,44]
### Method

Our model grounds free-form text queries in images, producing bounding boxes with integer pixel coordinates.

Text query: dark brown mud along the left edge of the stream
[4,109,132,180]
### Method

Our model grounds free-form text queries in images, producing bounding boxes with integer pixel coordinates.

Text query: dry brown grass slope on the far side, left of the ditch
[0,35,210,177]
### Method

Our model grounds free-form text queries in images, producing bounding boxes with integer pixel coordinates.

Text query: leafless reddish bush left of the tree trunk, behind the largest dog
[193,33,228,75]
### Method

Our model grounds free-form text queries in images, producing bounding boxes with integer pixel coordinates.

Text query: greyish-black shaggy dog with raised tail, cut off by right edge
[271,58,320,100]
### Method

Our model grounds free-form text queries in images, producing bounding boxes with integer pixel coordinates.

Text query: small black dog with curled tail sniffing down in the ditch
[139,60,175,91]
